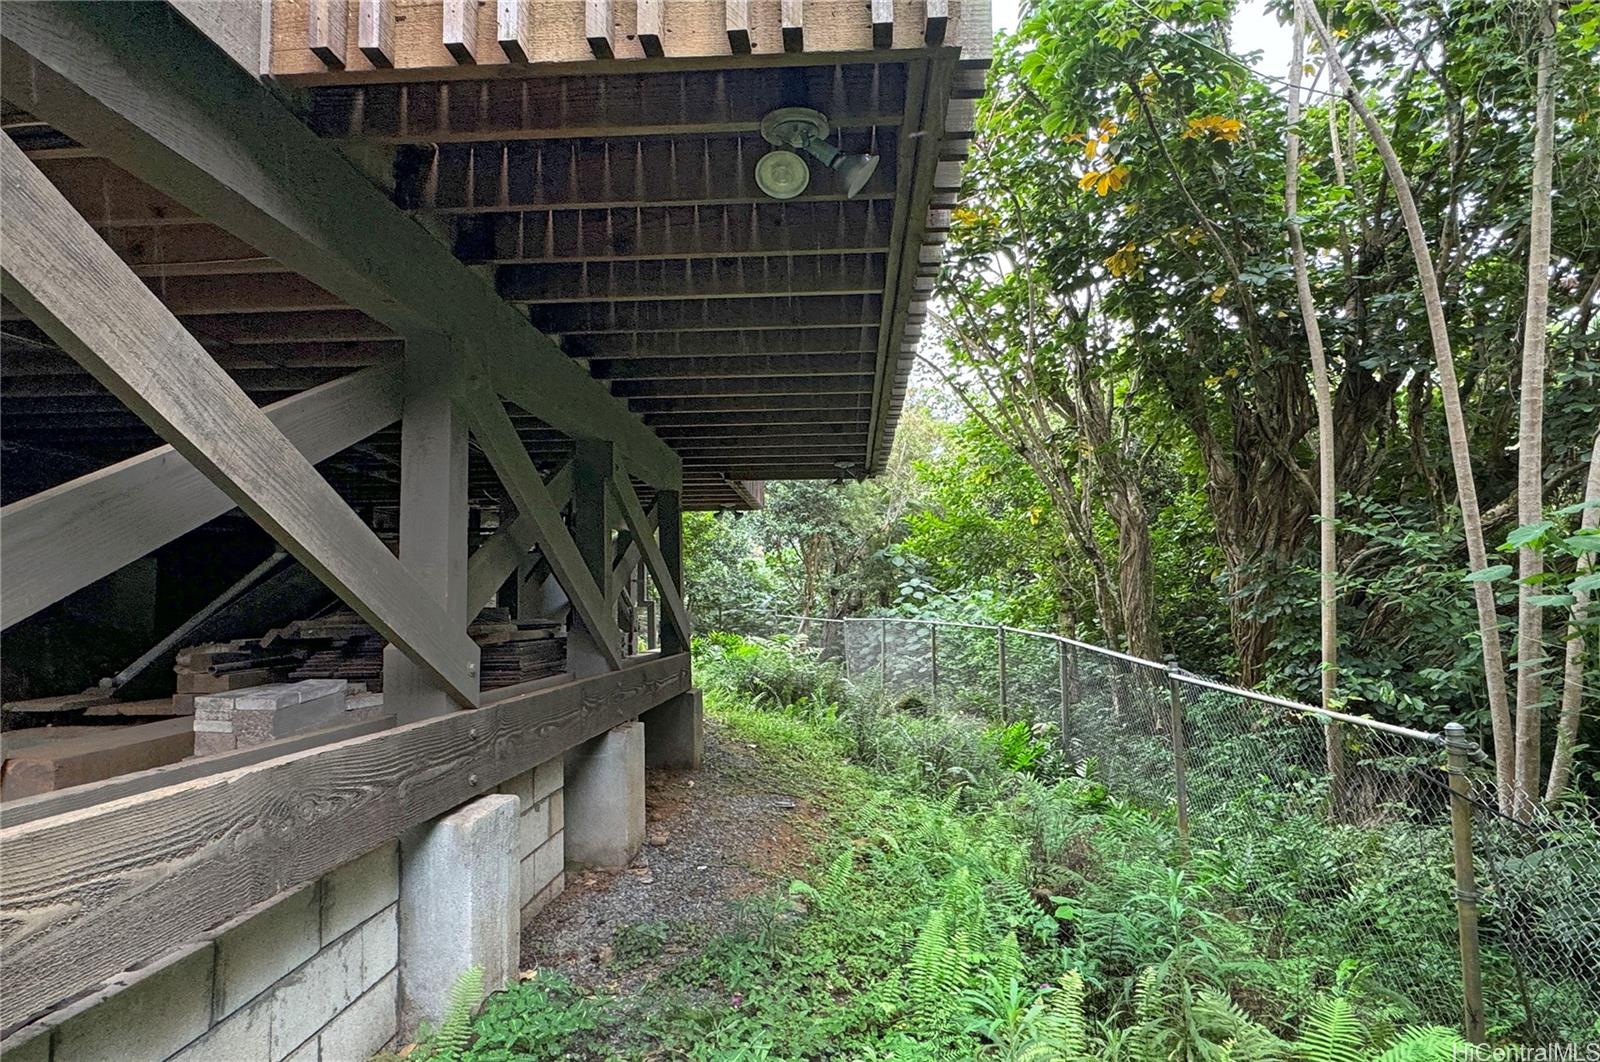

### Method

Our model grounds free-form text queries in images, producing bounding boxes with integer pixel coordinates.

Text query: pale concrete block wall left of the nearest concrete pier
[6,843,400,1062]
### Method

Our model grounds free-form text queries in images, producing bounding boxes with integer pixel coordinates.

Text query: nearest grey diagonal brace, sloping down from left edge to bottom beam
[0,136,478,704]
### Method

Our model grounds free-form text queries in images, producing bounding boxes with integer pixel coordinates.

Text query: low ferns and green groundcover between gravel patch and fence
[416,637,1600,1062]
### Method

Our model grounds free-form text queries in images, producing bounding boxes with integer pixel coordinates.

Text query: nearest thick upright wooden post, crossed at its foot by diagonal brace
[384,336,474,723]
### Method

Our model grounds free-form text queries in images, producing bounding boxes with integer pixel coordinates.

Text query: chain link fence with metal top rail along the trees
[723,614,1600,1044]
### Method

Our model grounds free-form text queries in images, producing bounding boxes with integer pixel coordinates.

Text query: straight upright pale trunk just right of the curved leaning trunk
[1517,3,1555,816]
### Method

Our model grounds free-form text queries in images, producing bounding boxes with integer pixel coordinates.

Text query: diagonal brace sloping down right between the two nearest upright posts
[458,384,621,667]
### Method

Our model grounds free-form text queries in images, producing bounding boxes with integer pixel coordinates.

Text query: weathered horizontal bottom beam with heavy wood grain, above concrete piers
[0,654,690,1036]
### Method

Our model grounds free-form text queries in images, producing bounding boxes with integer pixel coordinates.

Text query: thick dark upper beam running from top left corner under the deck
[0,3,678,486]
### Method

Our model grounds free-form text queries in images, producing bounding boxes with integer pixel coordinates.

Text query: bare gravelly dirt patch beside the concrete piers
[522,718,821,992]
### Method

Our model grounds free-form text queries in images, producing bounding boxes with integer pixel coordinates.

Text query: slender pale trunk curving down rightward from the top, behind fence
[1296,0,1517,812]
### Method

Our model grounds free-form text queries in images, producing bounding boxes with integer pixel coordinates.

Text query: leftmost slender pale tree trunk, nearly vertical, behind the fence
[1283,4,1349,796]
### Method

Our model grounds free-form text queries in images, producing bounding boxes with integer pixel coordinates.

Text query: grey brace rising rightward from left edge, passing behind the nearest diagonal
[0,366,400,627]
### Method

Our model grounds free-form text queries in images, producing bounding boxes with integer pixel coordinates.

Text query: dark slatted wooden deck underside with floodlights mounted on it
[0,0,987,510]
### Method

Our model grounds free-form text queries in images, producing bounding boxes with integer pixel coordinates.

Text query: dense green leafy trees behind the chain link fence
[690,0,1600,792]
